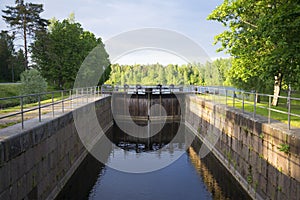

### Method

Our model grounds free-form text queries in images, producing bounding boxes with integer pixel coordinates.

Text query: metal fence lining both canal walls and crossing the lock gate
[0,85,300,130]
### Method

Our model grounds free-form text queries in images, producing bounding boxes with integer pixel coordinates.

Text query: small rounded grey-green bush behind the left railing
[20,69,47,103]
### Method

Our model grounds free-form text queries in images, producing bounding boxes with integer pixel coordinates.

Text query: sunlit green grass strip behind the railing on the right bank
[201,93,300,127]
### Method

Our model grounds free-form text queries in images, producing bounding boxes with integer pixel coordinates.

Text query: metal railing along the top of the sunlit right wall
[195,86,300,130]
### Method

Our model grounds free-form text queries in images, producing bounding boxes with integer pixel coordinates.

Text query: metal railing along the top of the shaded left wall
[0,86,102,129]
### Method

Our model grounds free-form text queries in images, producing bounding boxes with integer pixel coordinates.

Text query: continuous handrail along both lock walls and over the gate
[0,85,300,130]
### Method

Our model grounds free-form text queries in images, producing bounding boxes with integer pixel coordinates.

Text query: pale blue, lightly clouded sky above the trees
[0,0,229,64]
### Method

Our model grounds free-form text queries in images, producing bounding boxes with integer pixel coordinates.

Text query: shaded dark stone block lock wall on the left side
[0,97,112,200]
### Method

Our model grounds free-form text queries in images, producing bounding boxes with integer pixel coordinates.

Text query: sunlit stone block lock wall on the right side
[185,96,300,200]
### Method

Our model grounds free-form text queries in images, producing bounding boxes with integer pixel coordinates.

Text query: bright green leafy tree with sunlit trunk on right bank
[208,0,300,105]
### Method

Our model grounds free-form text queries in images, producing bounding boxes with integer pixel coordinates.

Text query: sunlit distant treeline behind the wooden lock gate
[106,59,231,85]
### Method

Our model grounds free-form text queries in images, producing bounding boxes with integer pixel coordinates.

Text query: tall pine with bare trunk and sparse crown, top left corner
[2,0,48,69]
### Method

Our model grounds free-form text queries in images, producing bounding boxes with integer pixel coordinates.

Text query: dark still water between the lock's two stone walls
[57,123,250,200]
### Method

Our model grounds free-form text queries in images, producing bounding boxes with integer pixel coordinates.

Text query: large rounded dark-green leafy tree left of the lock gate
[32,16,110,89]
